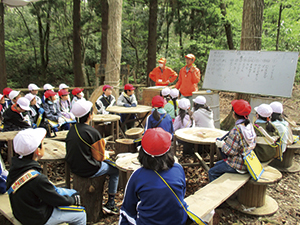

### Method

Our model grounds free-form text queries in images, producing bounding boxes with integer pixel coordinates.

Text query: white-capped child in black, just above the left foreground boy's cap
[3,97,30,131]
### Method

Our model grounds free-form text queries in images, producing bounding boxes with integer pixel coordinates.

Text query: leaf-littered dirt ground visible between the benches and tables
[0,85,300,225]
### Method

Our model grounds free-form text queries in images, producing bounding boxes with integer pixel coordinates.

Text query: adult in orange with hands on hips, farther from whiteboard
[149,58,178,86]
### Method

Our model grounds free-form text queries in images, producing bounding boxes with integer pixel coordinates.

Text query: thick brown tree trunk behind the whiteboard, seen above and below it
[221,0,264,130]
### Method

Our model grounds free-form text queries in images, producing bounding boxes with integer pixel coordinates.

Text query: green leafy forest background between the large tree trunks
[0,0,300,88]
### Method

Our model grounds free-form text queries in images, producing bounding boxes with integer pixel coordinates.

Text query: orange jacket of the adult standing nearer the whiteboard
[175,66,201,97]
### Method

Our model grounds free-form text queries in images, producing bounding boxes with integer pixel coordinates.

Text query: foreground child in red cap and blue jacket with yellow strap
[119,127,188,225]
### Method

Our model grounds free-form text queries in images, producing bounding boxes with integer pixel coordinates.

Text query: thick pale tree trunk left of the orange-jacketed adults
[104,0,123,98]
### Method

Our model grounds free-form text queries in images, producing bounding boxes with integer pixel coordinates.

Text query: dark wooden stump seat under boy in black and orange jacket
[73,174,106,223]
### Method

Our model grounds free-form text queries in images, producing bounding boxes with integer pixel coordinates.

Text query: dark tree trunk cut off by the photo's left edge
[0,2,7,91]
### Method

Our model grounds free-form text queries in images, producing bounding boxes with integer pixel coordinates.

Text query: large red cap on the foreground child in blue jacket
[142,127,172,156]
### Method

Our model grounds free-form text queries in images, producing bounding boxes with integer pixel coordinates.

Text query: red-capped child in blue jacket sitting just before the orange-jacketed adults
[145,95,174,135]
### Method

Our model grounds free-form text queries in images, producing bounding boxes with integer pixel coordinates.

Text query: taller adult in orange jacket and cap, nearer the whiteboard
[175,54,201,101]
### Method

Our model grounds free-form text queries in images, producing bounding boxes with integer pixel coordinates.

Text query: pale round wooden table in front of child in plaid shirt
[173,127,228,167]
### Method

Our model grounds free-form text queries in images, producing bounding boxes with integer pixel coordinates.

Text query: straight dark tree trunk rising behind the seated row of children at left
[73,0,84,87]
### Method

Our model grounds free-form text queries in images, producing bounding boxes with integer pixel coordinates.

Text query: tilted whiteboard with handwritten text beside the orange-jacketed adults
[203,50,298,97]
